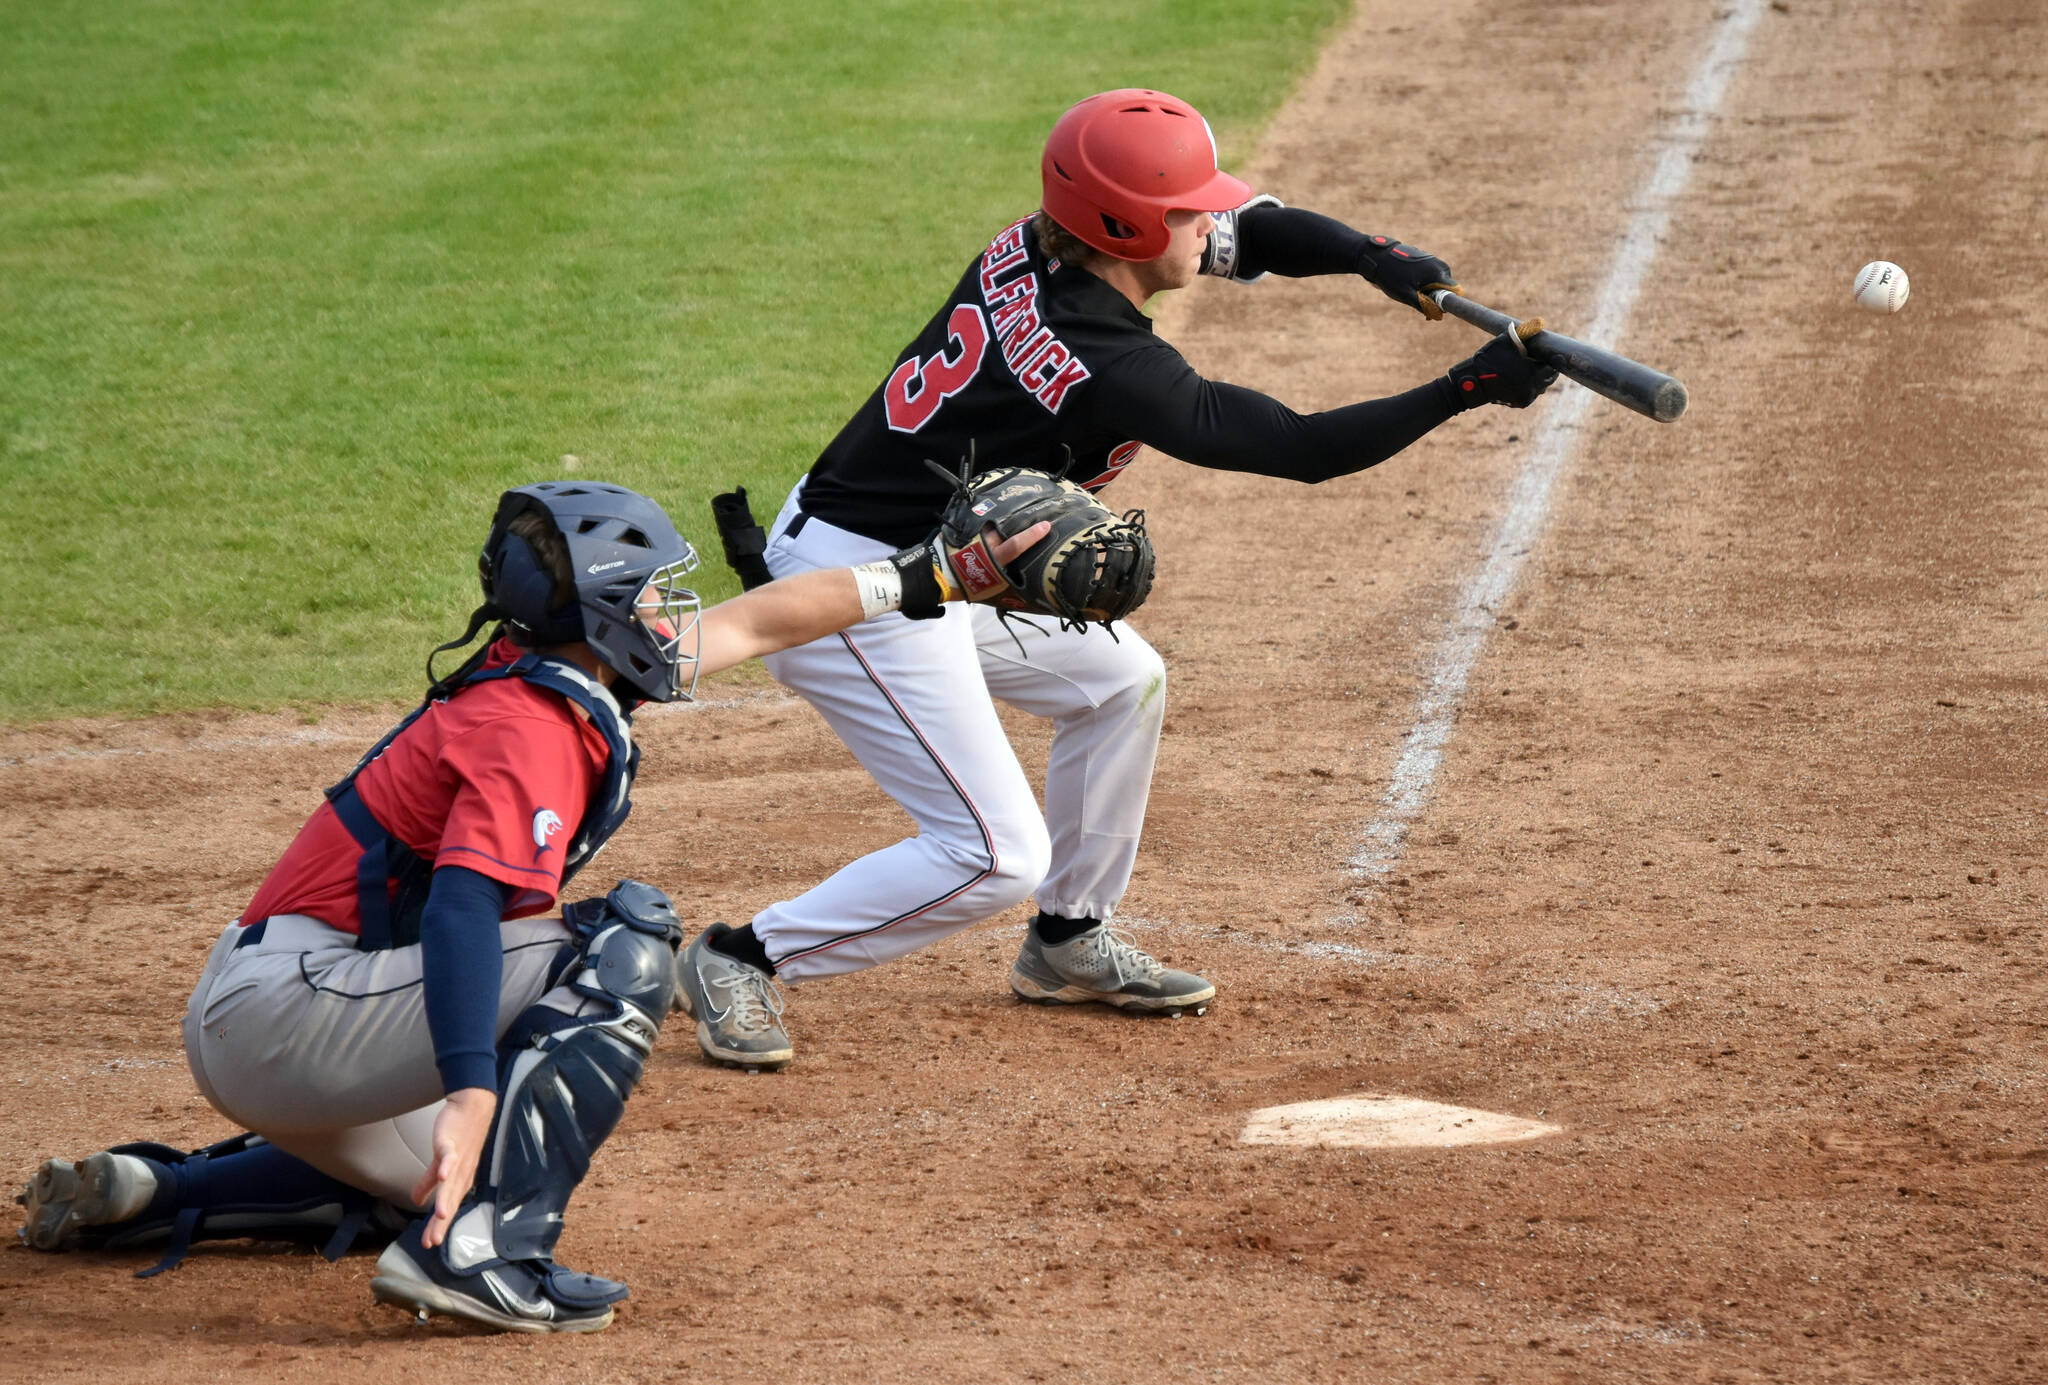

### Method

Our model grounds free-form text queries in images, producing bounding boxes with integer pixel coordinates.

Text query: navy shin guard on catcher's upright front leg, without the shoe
[446,881,682,1270]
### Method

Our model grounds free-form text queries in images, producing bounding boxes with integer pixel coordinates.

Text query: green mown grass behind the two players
[0,0,1348,721]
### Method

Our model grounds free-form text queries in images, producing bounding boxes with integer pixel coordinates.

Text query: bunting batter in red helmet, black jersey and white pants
[682,90,1554,1067]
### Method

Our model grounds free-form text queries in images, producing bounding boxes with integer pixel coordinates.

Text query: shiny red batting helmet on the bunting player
[1040,86,1251,260]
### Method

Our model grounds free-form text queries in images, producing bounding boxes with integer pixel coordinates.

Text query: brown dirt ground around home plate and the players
[0,0,2048,1383]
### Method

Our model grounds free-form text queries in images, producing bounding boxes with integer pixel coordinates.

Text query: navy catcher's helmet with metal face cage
[477,481,700,703]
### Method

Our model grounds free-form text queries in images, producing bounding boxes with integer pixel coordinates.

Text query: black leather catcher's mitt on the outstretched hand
[928,461,1153,629]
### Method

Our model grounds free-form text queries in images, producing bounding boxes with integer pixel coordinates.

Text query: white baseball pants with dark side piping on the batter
[754,484,1165,981]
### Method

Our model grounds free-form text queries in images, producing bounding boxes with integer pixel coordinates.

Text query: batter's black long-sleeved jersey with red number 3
[803,199,1458,545]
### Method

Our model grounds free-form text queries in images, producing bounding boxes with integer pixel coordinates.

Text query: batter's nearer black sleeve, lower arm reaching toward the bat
[1085,342,1458,481]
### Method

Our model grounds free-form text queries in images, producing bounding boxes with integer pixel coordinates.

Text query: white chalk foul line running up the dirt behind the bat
[1350,0,1765,881]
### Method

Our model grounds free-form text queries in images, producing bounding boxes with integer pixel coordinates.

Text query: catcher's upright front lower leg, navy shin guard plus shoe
[371,881,682,1332]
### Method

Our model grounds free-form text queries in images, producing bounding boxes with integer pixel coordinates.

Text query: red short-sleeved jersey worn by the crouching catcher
[242,639,610,932]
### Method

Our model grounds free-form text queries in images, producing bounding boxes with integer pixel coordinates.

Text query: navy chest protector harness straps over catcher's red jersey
[328,654,639,953]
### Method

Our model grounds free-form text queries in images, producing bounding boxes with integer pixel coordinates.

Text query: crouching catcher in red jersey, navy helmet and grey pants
[18,481,1047,1332]
